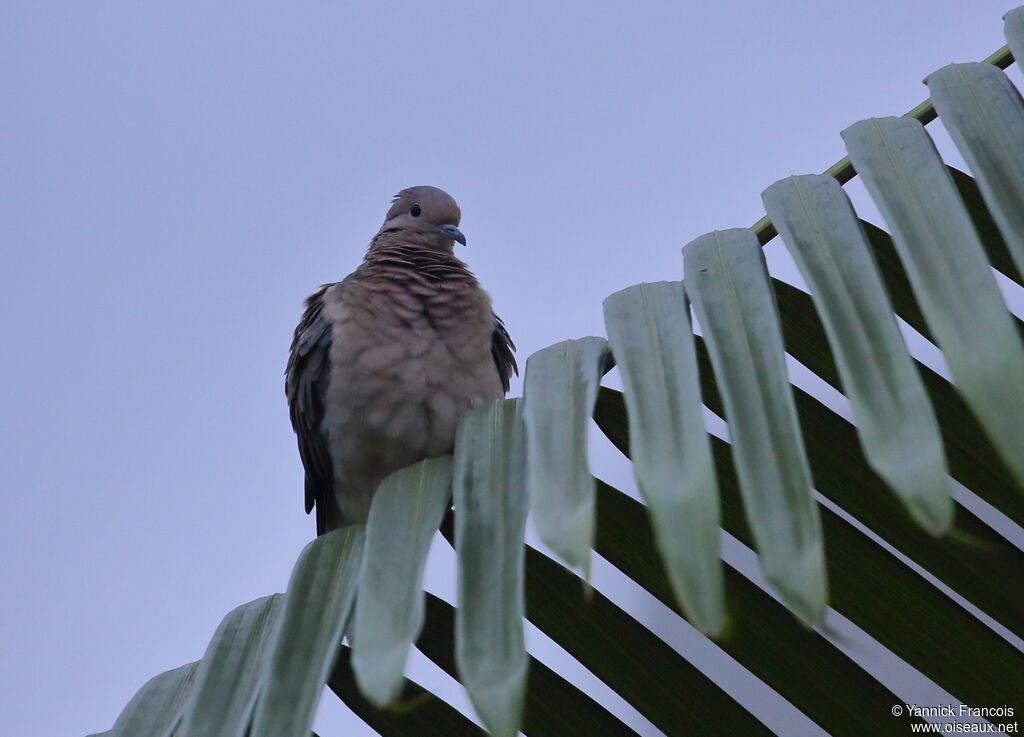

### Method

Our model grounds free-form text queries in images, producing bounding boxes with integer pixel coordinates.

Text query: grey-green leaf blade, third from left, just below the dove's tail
[251,526,364,737]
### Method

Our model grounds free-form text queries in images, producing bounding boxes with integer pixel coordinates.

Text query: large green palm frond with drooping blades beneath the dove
[90,8,1024,737]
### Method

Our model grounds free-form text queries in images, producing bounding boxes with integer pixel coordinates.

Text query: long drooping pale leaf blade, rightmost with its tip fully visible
[762,175,953,534]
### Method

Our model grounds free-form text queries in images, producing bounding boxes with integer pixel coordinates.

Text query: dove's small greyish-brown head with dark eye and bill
[378,186,466,251]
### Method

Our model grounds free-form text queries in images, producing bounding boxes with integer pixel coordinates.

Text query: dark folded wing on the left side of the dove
[285,284,334,534]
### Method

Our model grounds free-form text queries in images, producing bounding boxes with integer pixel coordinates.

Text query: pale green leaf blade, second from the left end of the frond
[176,594,281,737]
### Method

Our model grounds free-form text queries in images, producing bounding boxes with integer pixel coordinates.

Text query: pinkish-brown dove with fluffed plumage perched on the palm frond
[285,186,518,535]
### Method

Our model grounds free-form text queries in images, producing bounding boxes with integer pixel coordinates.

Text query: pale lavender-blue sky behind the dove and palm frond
[0,0,1018,737]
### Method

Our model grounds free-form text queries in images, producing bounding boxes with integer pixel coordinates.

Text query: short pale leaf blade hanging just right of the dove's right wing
[523,337,607,578]
